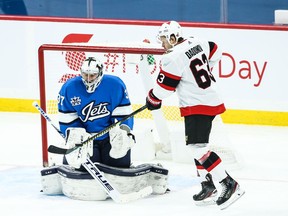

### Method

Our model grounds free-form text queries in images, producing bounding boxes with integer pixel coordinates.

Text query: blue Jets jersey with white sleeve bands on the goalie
[58,74,134,140]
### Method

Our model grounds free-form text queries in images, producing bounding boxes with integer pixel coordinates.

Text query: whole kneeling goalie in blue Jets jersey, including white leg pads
[41,57,168,200]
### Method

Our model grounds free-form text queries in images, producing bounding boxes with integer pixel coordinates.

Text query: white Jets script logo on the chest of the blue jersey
[80,101,110,122]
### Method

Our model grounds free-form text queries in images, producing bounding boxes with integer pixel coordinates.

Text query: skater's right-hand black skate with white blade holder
[216,174,245,210]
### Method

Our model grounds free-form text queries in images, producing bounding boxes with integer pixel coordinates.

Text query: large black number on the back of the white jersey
[190,54,216,89]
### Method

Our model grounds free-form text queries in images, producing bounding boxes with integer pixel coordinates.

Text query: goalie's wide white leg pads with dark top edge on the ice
[41,164,168,201]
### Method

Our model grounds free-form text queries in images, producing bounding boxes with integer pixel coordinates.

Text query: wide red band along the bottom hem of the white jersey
[180,104,226,116]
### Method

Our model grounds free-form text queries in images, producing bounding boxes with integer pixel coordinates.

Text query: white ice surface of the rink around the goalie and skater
[0,112,288,216]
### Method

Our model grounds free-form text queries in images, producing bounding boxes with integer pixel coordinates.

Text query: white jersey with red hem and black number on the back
[153,38,225,116]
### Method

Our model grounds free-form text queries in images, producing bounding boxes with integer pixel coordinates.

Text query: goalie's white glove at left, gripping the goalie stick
[65,128,93,169]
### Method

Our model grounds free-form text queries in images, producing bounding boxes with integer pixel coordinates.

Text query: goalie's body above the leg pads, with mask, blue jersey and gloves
[58,57,135,168]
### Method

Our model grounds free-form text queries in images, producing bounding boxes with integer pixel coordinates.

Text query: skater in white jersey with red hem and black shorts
[146,21,244,209]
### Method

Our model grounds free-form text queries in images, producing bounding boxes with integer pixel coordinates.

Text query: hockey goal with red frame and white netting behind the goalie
[38,42,241,169]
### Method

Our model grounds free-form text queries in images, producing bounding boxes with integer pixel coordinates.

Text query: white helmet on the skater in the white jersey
[157,21,183,42]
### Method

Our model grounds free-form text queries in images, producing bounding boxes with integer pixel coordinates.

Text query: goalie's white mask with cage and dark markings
[80,57,103,93]
